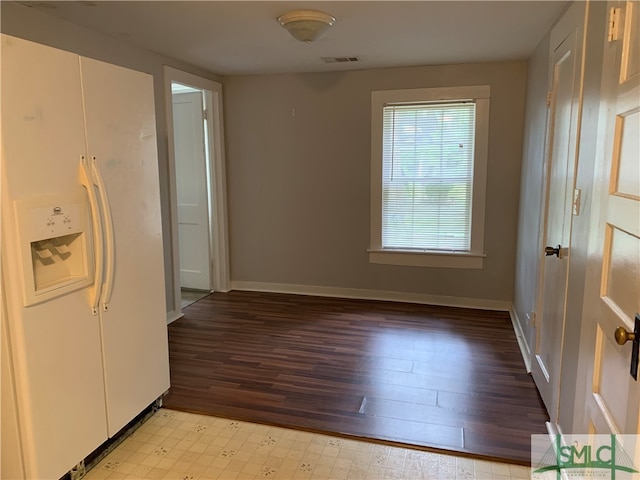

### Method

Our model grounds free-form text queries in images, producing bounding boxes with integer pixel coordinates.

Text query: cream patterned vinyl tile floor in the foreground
[85,408,530,480]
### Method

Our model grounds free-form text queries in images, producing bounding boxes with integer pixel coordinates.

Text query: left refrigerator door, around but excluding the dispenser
[0,35,107,478]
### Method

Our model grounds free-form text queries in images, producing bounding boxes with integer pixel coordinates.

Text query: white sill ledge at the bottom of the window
[367,249,486,269]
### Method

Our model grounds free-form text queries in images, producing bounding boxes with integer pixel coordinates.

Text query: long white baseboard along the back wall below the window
[231,280,511,312]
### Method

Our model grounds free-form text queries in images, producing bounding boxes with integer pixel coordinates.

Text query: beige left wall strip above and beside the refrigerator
[0,2,219,318]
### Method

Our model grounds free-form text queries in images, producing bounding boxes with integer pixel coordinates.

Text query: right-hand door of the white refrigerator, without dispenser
[81,58,169,435]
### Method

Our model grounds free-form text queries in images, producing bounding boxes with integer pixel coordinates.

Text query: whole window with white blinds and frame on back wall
[369,86,489,268]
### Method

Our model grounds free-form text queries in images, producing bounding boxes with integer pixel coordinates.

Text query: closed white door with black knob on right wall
[532,18,582,422]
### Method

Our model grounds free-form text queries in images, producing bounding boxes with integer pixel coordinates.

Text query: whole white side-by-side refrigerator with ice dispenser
[0,35,169,479]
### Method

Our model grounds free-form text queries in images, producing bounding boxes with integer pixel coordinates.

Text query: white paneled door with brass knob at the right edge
[579,1,640,438]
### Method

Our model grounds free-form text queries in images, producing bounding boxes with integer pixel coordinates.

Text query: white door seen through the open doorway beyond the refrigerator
[173,91,211,290]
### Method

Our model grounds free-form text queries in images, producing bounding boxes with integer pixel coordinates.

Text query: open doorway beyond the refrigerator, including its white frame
[165,67,229,319]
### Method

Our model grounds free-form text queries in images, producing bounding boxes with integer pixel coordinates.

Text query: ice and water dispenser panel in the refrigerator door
[15,191,93,306]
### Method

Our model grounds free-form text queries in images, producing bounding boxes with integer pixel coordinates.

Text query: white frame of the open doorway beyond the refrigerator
[164,65,231,322]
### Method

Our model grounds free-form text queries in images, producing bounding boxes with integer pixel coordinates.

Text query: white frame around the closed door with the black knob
[531,1,608,434]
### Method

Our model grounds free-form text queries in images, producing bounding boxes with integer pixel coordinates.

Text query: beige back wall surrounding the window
[224,62,527,302]
